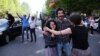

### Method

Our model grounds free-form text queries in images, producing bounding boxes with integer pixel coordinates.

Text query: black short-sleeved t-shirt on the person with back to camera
[70,26,89,50]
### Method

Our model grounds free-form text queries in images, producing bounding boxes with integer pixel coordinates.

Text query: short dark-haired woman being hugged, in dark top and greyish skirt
[42,20,58,56]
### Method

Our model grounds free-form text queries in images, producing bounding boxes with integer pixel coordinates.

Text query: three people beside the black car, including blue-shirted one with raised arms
[6,11,36,43]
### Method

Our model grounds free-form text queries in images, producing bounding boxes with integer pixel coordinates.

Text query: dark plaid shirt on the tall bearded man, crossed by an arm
[56,19,70,43]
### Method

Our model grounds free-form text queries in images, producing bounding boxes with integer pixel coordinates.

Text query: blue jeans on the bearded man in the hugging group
[57,42,71,56]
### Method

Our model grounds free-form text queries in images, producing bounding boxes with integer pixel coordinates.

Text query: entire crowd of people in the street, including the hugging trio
[6,8,100,56]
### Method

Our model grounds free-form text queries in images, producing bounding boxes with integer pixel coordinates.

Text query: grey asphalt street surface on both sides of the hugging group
[0,29,100,56]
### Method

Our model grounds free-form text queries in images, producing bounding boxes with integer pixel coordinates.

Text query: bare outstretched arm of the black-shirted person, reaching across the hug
[44,27,72,35]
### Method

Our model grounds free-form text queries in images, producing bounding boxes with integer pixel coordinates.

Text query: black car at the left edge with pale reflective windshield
[0,19,21,45]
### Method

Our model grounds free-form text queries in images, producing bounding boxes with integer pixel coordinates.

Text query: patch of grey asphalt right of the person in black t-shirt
[89,32,100,56]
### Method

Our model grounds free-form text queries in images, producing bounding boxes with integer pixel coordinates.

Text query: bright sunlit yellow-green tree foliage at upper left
[0,0,29,17]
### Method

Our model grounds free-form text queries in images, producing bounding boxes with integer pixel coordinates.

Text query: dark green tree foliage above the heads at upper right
[47,0,100,13]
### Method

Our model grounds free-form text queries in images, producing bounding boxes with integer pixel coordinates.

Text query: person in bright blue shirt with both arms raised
[17,13,30,42]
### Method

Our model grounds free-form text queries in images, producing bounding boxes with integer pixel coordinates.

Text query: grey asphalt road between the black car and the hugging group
[0,26,44,56]
